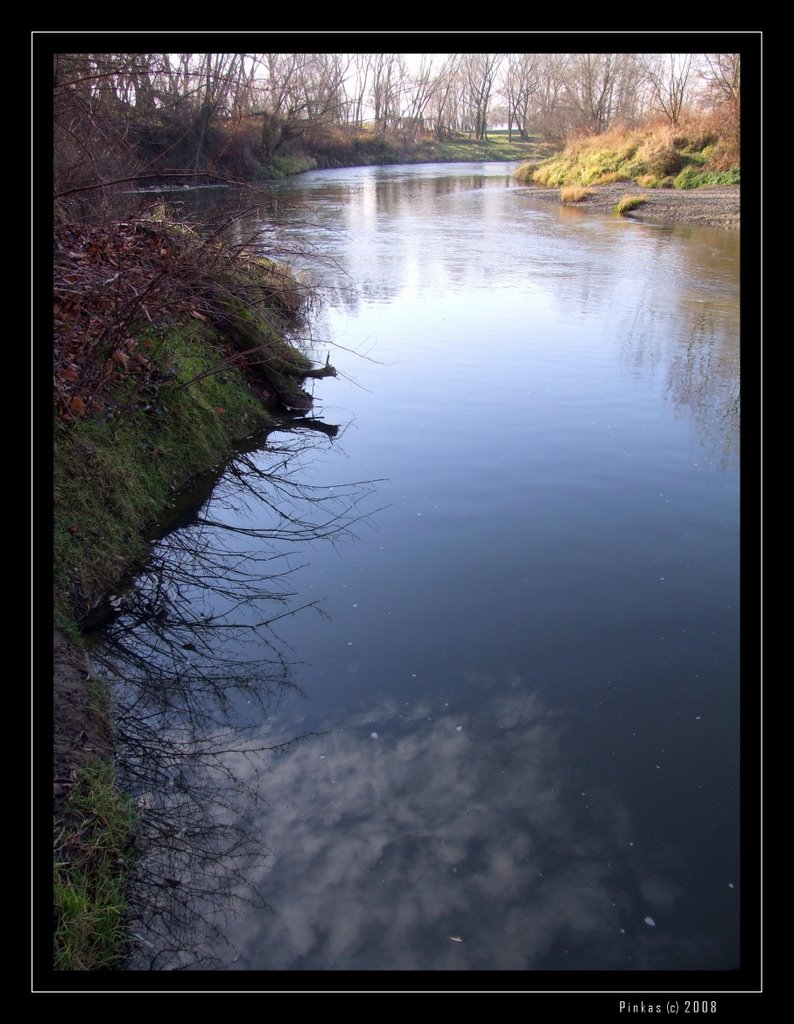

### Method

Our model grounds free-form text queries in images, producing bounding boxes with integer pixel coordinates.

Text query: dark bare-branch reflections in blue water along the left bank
[92,421,376,970]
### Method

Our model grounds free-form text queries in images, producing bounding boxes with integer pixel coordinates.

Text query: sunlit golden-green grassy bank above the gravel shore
[515,121,740,188]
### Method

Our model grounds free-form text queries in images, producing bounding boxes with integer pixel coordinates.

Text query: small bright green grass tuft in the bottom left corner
[53,761,136,971]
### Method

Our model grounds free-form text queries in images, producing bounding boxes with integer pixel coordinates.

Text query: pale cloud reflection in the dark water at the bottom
[216,678,721,970]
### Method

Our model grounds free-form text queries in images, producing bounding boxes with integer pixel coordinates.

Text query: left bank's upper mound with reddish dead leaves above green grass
[53,217,311,638]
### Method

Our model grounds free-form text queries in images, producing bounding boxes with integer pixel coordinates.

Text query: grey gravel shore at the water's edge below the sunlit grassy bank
[526,181,740,229]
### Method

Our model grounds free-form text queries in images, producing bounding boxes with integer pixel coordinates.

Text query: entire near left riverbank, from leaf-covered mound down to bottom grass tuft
[53,211,334,971]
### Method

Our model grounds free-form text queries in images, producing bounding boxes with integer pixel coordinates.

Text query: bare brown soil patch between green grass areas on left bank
[52,630,113,817]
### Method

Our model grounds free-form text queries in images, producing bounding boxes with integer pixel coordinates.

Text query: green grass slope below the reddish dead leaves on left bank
[53,322,274,635]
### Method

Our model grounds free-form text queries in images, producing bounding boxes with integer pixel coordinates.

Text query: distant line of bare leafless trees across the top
[53,53,741,193]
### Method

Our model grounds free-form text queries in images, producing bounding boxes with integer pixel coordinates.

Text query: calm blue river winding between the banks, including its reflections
[94,164,741,971]
